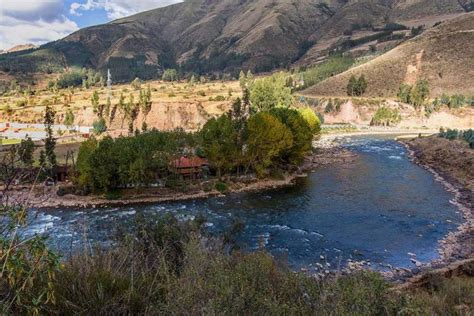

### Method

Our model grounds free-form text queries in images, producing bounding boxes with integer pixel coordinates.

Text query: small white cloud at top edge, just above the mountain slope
[69,0,182,19]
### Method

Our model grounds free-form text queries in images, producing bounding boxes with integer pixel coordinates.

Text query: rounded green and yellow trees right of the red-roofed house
[201,104,320,176]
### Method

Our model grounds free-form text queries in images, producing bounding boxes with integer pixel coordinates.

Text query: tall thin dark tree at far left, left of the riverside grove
[40,105,56,179]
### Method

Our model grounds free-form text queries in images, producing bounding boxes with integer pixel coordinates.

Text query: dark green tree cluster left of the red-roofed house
[74,130,196,193]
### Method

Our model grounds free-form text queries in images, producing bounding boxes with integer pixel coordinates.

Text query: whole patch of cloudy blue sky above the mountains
[0,0,182,50]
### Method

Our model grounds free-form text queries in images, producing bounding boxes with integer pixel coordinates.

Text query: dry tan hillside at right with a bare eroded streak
[303,12,474,97]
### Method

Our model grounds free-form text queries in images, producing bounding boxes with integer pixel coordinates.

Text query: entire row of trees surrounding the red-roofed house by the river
[75,99,320,193]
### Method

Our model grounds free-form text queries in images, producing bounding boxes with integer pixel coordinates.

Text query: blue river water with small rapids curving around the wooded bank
[24,136,462,269]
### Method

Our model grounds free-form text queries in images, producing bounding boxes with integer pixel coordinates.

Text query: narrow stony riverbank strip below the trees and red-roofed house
[10,137,355,209]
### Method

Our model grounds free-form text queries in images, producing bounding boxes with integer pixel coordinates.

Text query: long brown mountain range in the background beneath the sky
[0,0,471,80]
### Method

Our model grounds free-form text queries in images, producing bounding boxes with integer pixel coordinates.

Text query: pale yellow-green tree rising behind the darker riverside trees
[247,73,293,113]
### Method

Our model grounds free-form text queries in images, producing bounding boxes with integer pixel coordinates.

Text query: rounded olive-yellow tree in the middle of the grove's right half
[246,112,293,176]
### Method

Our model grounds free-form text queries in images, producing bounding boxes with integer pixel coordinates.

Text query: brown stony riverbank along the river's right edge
[398,136,474,280]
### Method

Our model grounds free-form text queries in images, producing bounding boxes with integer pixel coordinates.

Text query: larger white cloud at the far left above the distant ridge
[0,0,78,49]
